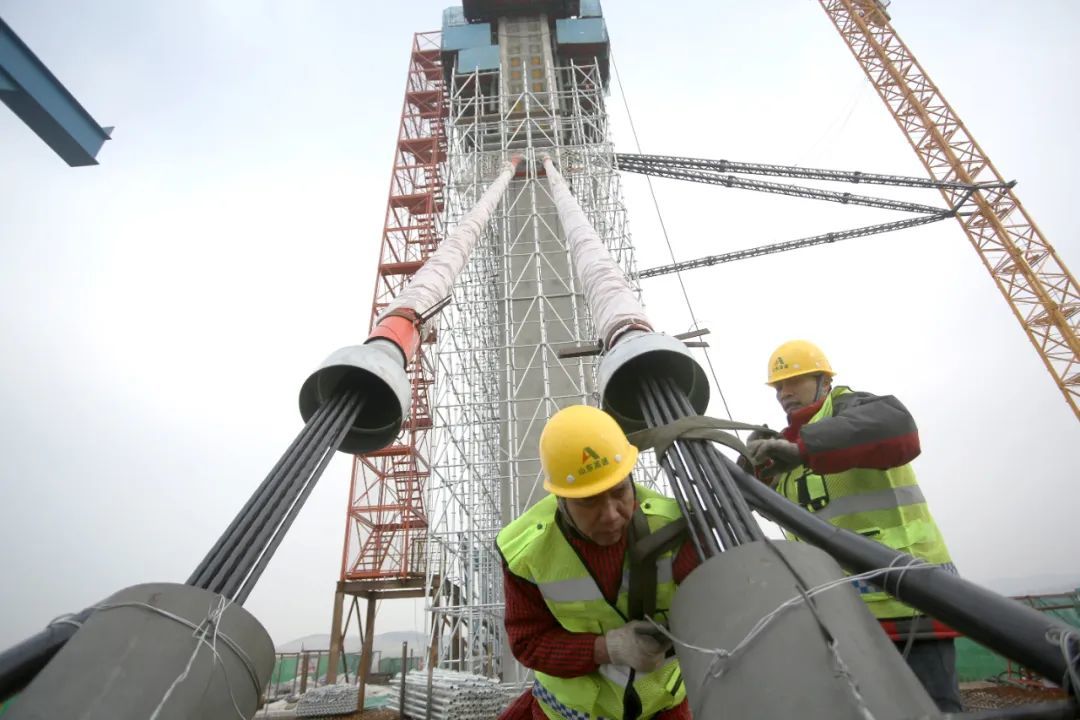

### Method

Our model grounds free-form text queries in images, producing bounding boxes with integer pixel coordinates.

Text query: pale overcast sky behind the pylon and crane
[0,0,1080,647]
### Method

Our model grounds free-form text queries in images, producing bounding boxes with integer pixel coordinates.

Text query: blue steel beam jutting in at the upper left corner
[0,18,112,167]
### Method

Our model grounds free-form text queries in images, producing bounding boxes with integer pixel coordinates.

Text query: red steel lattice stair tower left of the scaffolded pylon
[341,31,447,581]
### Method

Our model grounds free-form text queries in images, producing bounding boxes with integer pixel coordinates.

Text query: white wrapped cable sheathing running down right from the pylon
[543,155,651,343]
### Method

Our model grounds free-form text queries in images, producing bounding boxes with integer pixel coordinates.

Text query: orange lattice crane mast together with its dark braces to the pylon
[618,0,1080,419]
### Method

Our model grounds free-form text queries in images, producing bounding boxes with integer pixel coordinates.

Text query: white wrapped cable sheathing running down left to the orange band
[382,162,517,317]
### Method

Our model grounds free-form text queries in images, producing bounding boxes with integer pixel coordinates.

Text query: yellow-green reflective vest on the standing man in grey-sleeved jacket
[773,388,953,620]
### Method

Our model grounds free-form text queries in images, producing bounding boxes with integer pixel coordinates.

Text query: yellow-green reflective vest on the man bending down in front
[497,486,686,720]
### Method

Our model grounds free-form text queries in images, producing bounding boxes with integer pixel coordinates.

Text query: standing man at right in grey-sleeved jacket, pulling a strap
[747,340,962,711]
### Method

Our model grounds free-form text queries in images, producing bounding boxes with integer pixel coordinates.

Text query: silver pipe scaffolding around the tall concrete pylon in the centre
[419,16,659,680]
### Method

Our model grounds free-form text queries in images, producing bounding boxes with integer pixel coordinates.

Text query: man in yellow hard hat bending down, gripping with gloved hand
[497,405,698,720]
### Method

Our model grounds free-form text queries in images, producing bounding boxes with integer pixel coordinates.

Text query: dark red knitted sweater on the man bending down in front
[499,518,699,720]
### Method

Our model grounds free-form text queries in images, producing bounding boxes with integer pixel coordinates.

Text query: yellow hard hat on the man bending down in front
[540,405,637,498]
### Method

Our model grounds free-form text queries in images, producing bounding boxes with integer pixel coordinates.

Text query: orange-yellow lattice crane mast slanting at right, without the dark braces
[819,0,1080,419]
